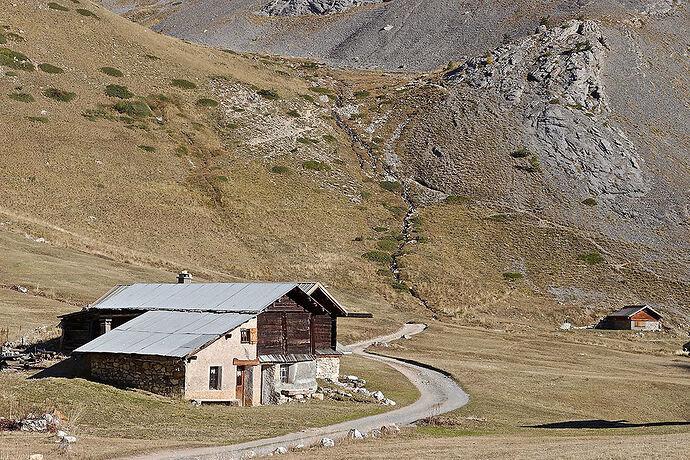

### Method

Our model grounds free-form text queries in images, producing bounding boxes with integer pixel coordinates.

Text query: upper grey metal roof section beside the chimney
[91,283,297,312]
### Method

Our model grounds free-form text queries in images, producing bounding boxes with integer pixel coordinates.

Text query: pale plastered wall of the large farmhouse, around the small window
[185,318,261,404]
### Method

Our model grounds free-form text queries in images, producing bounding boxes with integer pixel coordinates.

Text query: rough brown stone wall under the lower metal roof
[87,354,185,398]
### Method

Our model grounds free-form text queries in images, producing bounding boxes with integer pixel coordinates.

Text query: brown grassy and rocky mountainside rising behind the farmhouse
[0,0,690,326]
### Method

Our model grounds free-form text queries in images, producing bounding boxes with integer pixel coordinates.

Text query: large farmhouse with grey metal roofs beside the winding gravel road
[60,272,371,406]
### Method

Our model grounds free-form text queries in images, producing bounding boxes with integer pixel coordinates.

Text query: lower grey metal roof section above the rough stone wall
[75,311,256,358]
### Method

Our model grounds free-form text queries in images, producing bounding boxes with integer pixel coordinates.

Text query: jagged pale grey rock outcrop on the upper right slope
[447,20,648,200]
